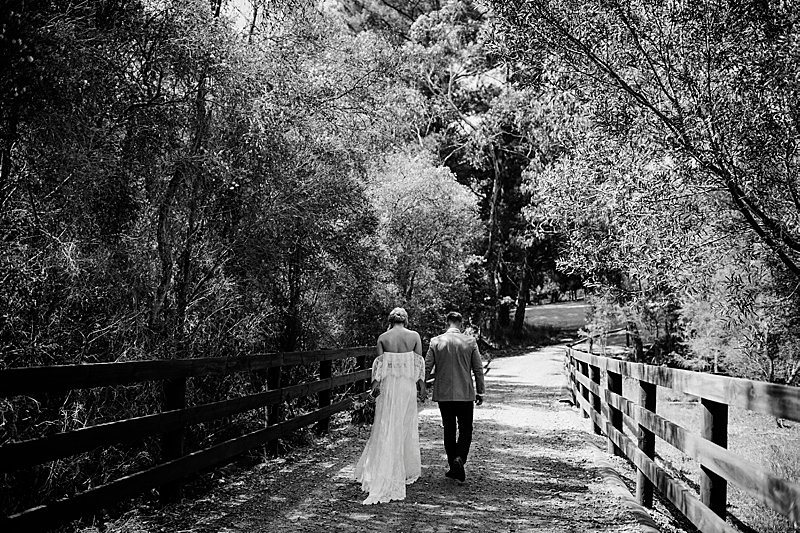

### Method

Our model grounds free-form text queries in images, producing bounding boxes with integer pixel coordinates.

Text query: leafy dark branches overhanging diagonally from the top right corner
[496,0,800,278]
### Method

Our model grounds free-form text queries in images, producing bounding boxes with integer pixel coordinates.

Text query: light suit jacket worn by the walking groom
[425,328,484,402]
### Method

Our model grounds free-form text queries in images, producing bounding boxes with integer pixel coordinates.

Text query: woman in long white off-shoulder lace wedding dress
[355,307,427,505]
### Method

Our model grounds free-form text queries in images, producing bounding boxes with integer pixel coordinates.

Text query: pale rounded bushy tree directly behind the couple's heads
[369,148,482,333]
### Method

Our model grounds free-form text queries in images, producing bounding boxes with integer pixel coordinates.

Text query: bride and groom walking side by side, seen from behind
[355,307,484,504]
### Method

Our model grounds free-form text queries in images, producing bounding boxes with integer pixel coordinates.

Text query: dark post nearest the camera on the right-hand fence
[700,398,728,519]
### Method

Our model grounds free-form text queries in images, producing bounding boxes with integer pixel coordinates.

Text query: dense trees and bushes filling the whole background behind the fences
[0,0,800,528]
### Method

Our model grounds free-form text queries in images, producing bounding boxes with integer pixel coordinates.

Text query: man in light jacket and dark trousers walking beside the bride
[425,311,484,482]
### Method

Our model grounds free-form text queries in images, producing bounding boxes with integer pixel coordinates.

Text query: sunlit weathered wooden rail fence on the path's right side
[567,347,800,533]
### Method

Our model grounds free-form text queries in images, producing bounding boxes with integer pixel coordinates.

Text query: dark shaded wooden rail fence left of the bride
[0,347,375,533]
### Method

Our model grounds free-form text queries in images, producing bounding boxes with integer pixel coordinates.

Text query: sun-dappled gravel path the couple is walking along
[134,348,642,533]
